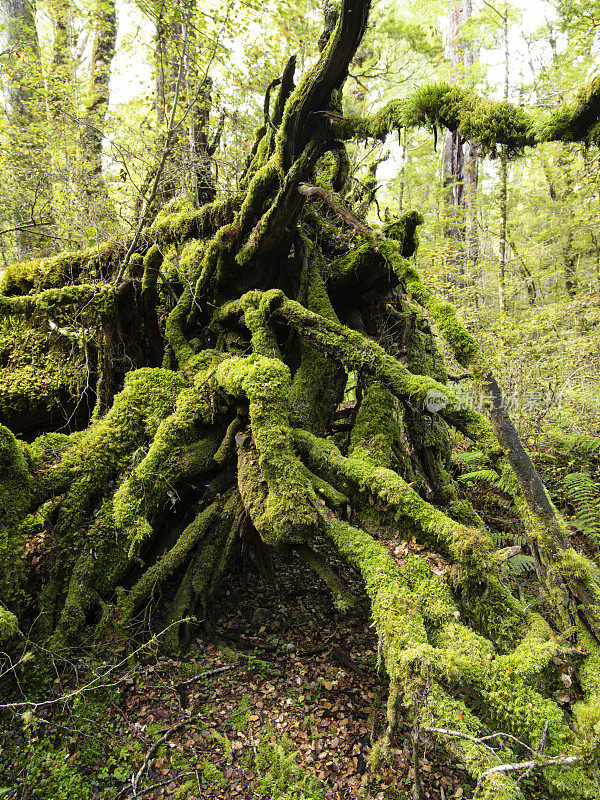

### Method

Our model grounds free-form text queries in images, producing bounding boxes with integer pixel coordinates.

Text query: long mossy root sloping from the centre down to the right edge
[260,291,600,640]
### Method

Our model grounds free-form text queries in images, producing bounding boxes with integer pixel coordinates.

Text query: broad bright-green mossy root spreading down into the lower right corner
[321,507,597,800]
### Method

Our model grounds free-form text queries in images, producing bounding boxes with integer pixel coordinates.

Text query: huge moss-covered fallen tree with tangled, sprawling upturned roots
[0,0,600,800]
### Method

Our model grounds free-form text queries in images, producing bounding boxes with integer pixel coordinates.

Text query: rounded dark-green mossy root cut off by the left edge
[0,418,32,608]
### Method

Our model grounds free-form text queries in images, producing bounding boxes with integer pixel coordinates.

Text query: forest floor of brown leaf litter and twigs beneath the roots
[0,541,543,800]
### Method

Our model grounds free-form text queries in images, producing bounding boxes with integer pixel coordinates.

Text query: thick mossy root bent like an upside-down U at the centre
[115,354,316,555]
